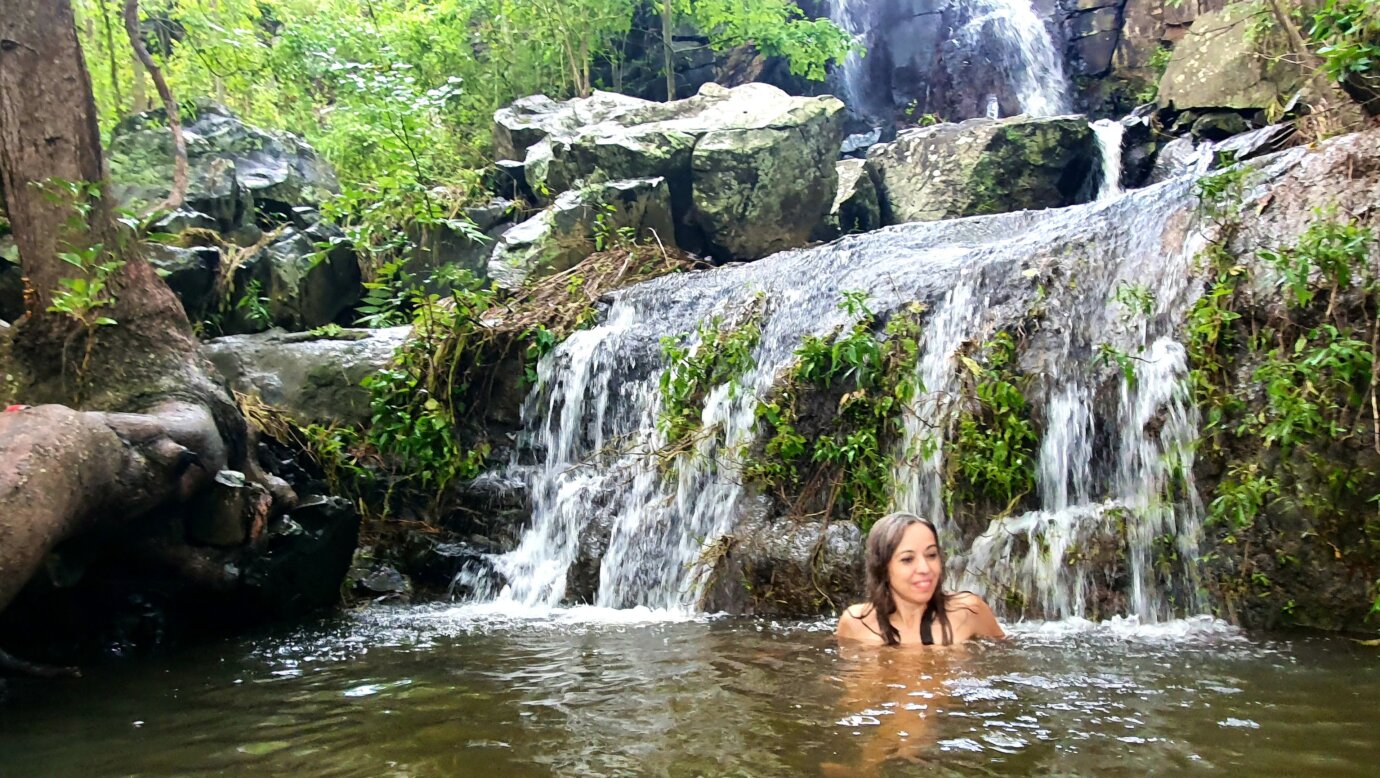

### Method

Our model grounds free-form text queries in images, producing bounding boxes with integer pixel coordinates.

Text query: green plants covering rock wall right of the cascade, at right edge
[1187,186,1380,624]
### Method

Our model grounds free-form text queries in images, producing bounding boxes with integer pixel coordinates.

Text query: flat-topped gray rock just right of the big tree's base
[201,327,411,423]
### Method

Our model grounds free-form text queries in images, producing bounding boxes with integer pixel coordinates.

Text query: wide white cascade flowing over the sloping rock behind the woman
[497,162,1225,621]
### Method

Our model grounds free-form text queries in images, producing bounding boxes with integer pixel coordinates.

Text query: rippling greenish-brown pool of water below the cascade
[0,607,1380,778]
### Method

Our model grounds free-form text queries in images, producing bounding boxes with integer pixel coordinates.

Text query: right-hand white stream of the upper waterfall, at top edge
[956,0,1070,116]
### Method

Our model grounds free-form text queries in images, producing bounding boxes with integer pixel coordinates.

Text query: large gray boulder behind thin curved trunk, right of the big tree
[106,101,339,232]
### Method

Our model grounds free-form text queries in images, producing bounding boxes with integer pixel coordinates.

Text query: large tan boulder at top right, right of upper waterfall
[1159,3,1305,110]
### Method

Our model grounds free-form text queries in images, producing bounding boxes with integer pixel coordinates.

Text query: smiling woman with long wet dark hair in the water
[835,513,1006,646]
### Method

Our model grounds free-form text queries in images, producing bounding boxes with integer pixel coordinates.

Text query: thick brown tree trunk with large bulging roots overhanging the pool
[0,0,291,670]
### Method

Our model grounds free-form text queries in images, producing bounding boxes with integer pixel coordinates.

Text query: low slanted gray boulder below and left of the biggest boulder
[487,178,673,290]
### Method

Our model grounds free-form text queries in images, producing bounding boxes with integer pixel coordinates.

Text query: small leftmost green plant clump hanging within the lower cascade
[657,308,762,446]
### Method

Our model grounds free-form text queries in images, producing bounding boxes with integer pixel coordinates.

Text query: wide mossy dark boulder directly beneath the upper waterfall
[867,116,1098,223]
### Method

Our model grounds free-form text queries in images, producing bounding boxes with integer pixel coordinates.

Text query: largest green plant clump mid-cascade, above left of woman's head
[744,291,923,530]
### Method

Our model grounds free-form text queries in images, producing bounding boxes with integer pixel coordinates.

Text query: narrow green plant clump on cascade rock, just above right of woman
[947,332,1039,506]
